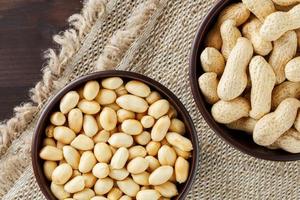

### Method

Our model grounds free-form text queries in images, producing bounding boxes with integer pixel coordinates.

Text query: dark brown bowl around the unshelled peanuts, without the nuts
[190,0,300,161]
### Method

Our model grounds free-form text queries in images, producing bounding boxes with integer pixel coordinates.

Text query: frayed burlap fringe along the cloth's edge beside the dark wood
[0,0,107,156]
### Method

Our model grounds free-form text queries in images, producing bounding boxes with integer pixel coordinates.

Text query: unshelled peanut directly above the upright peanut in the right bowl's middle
[242,17,273,56]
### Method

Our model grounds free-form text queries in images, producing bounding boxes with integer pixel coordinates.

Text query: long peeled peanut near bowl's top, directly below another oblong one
[116,94,148,113]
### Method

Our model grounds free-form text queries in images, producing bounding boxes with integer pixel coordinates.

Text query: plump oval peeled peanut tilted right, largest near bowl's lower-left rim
[51,163,73,185]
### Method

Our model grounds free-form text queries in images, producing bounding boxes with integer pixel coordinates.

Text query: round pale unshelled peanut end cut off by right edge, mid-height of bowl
[284,56,300,82]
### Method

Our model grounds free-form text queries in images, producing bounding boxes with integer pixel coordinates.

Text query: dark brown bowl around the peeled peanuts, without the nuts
[31,71,200,200]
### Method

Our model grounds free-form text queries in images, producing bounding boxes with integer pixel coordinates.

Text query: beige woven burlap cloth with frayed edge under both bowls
[0,0,300,199]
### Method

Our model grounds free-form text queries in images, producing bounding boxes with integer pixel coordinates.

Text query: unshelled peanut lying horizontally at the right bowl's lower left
[211,97,250,124]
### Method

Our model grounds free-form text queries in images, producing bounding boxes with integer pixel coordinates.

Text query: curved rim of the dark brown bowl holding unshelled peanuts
[189,0,300,161]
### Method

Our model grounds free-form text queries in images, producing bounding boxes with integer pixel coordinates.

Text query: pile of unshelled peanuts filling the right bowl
[198,0,300,153]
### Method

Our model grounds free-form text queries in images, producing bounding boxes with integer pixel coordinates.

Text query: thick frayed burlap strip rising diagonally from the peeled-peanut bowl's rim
[95,0,159,71]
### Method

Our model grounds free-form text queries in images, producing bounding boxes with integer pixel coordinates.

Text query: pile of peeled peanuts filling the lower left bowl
[39,77,193,200]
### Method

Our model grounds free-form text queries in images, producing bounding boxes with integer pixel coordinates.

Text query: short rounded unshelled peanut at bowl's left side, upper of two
[200,47,225,75]
